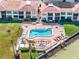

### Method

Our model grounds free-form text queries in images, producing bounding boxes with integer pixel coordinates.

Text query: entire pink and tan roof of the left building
[0,0,38,11]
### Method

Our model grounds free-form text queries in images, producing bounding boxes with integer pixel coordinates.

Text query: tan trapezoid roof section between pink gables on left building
[1,1,20,11]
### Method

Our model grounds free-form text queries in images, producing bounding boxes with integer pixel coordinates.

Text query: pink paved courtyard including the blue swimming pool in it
[20,24,65,51]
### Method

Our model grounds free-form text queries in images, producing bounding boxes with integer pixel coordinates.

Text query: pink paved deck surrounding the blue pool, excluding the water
[22,24,65,50]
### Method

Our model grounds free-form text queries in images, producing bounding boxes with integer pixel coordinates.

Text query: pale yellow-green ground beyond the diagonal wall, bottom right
[49,39,79,59]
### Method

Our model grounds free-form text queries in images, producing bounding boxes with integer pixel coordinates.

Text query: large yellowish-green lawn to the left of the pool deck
[0,23,22,59]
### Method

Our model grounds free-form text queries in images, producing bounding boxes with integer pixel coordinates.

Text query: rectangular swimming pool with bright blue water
[29,28,53,38]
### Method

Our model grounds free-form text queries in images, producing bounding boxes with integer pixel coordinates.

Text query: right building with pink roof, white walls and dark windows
[41,2,79,22]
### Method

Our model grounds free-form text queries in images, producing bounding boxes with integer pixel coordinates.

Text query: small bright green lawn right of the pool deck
[63,24,79,36]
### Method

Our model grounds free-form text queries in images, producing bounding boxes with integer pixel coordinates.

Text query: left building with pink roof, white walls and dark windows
[0,1,38,20]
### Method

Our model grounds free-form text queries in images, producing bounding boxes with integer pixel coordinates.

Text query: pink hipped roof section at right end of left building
[19,1,38,11]
